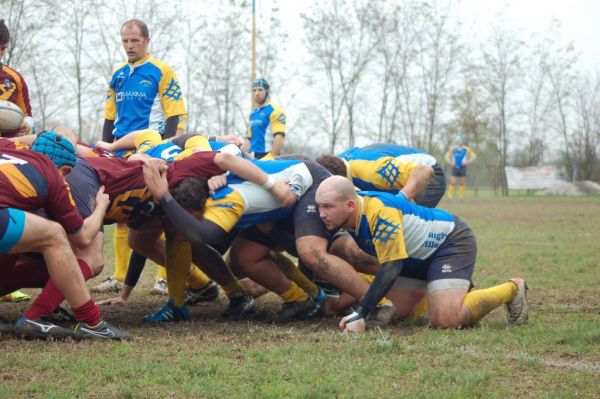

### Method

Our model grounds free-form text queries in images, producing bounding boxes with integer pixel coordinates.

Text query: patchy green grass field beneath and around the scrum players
[0,197,600,398]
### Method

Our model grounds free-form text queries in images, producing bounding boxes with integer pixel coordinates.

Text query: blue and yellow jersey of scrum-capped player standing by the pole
[246,102,287,153]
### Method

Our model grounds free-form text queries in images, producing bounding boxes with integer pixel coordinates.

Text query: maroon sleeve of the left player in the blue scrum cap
[45,168,83,234]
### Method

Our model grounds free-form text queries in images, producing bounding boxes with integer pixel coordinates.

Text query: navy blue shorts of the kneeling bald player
[396,216,477,293]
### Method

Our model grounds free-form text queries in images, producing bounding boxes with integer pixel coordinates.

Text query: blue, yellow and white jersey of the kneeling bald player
[351,191,454,263]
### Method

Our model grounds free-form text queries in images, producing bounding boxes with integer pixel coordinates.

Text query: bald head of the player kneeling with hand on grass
[315,176,358,231]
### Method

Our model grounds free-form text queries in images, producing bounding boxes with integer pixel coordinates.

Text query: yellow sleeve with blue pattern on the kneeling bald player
[369,200,408,264]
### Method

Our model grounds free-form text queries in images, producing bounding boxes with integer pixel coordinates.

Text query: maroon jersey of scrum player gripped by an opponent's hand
[85,151,224,223]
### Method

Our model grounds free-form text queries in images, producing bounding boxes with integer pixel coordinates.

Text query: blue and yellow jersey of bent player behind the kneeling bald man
[339,144,436,194]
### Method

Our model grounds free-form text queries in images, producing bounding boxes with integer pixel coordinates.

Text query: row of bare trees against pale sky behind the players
[0,0,600,194]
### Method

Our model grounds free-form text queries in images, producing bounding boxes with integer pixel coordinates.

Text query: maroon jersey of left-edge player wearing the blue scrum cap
[0,138,83,233]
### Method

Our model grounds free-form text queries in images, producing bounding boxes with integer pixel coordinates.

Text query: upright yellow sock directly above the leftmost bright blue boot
[166,241,192,307]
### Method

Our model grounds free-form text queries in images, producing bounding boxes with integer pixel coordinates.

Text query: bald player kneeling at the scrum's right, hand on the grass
[316,176,528,332]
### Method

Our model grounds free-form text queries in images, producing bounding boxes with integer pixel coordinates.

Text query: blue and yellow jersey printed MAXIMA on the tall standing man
[104,54,186,139]
